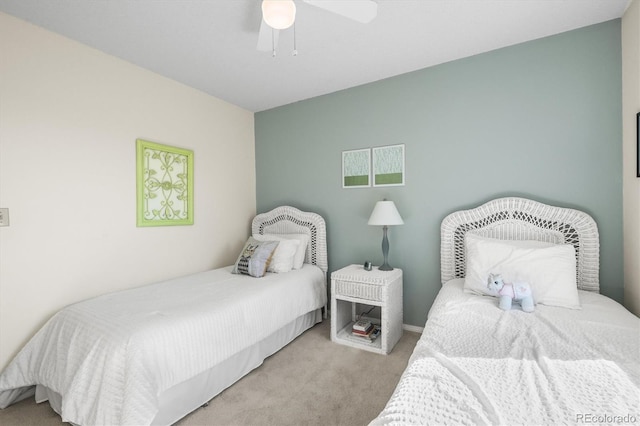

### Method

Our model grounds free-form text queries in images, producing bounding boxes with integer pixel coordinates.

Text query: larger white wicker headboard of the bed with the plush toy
[440,198,600,292]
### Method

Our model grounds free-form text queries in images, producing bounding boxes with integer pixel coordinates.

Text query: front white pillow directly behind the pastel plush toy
[464,233,580,309]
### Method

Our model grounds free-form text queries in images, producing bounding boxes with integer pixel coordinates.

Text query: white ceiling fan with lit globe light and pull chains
[257,0,378,56]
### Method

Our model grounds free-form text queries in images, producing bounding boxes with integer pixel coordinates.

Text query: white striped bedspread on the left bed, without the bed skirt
[0,265,327,425]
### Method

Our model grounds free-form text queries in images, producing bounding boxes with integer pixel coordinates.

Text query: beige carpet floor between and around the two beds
[0,320,420,426]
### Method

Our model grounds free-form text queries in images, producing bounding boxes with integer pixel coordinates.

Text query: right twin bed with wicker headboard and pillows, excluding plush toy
[371,198,640,425]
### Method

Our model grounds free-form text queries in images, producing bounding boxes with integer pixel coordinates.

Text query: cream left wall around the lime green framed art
[0,13,256,369]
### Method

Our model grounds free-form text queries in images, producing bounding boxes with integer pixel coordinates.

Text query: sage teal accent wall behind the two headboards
[255,19,623,326]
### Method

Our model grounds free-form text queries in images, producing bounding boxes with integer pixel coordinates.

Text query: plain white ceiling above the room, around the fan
[0,0,631,112]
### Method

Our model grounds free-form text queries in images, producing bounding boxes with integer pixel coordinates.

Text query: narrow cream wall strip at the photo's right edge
[622,0,640,316]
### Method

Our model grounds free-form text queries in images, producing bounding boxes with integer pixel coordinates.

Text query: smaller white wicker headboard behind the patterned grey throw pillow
[251,206,328,277]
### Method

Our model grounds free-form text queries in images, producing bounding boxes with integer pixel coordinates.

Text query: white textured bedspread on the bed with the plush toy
[371,280,640,425]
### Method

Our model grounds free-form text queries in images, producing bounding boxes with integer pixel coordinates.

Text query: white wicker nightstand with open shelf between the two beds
[331,265,402,354]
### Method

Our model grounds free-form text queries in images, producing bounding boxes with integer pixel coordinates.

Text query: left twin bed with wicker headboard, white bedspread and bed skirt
[0,206,327,425]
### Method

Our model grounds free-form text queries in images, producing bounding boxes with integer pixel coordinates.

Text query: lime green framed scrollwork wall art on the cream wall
[136,139,193,227]
